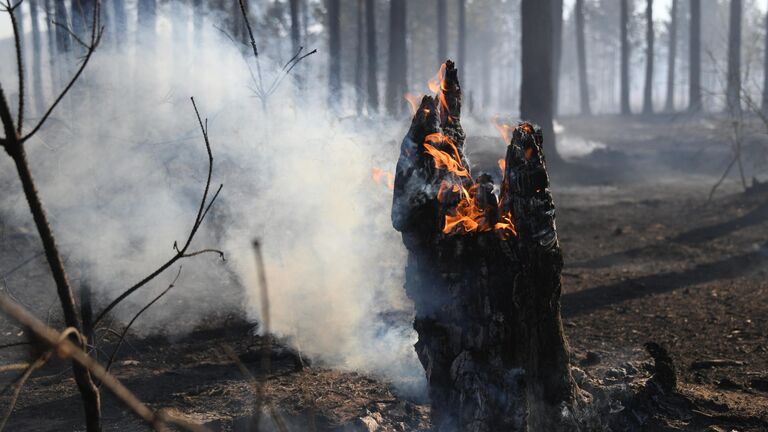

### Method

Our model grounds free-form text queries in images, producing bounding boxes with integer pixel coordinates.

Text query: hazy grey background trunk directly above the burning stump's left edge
[386,0,408,116]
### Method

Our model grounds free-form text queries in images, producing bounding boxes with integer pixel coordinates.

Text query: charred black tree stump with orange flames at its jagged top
[392,61,577,431]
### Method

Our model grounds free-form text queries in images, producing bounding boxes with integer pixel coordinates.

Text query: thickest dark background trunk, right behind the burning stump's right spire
[520,0,562,164]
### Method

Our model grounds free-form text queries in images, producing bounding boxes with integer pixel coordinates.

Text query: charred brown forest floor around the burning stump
[0,116,768,432]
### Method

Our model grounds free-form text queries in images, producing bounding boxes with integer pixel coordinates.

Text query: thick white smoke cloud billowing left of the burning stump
[0,6,424,396]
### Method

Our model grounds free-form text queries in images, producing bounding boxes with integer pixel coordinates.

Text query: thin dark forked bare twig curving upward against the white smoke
[93,98,224,326]
